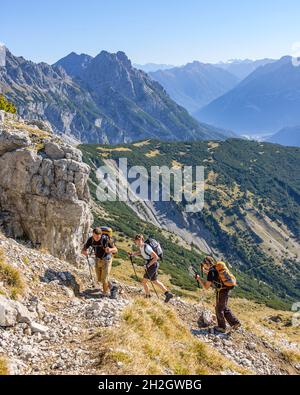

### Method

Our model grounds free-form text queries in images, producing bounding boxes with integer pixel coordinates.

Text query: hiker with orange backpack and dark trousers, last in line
[196,256,241,333]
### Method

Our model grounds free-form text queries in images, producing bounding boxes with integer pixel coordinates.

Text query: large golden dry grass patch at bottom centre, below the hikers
[93,298,245,375]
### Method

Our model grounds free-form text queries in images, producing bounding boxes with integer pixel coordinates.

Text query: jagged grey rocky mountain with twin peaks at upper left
[0,50,230,143]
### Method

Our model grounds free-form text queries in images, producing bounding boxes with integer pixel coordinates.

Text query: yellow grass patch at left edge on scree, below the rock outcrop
[0,249,24,299]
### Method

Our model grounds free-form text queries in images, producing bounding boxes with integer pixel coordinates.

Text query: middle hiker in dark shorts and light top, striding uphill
[129,234,173,303]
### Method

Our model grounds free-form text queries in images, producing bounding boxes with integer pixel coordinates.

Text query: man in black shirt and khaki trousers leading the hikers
[82,228,118,299]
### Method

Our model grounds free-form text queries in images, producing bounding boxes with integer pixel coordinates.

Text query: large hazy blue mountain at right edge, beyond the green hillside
[194,56,300,134]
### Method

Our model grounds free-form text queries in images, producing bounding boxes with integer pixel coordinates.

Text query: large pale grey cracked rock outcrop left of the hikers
[0,112,91,262]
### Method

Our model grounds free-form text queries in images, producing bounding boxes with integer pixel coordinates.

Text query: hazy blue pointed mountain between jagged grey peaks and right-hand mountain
[149,61,239,114]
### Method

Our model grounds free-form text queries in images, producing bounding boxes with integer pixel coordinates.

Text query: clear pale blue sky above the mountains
[0,0,300,65]
